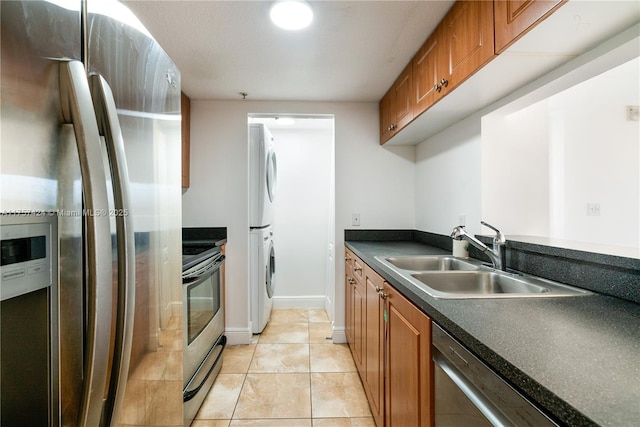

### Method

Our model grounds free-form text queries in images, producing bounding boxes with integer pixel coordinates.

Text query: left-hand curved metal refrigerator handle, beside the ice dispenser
[59,61,113,426]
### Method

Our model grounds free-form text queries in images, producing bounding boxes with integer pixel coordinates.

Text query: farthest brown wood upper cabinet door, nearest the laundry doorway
[379,64,413,144]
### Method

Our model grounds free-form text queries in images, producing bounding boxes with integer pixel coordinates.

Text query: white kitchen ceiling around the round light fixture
[123,0,453,102]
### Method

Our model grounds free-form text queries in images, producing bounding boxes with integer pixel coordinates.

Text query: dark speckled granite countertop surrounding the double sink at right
[345,241,640,426]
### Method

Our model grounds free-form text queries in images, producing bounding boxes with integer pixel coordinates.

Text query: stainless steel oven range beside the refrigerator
[182,247,227,426]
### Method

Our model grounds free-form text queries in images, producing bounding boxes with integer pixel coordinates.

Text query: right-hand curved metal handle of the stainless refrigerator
[89,75,136,425]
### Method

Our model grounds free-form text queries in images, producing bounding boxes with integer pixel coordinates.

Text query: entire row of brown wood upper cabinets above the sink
[380,0,566,144]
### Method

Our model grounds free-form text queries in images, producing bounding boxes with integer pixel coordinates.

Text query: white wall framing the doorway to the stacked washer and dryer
[182,100,415,344]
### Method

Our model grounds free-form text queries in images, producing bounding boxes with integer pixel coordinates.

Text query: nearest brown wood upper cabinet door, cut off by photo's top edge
[493,0,566,53]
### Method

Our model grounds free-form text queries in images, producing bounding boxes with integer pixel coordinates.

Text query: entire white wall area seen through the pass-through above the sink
[482,59,640,248]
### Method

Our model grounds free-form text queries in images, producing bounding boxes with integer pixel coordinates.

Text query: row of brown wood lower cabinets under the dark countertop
[345,249,434,427]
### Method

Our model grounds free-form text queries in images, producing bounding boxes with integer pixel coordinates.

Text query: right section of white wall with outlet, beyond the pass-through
[550,59,640,248]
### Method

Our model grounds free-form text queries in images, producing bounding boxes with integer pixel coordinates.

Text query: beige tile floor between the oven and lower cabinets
[192,309,375,427]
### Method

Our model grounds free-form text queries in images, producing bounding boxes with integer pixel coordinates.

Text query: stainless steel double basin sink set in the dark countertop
[376,255,591,299]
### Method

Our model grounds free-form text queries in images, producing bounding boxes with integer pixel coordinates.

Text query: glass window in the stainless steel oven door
[187,274,220,344]
